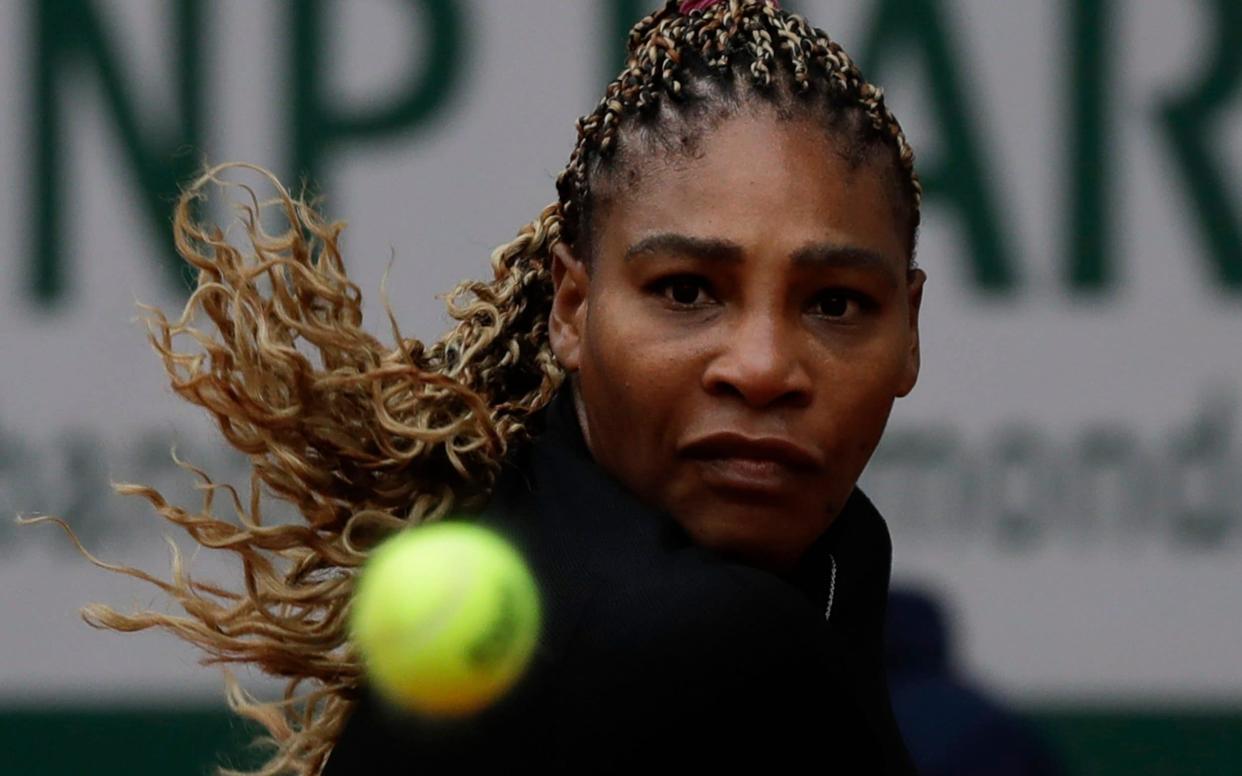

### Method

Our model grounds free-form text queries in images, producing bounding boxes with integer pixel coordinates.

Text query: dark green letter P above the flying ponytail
[289,0,465,191]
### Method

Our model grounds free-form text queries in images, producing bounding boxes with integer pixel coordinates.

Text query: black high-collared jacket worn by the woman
[324,390,913,776]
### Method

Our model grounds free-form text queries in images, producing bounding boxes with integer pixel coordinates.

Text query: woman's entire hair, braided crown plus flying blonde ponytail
[36,0,920,776]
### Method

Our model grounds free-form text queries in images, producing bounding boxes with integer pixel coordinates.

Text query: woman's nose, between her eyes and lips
[703,312,812,408]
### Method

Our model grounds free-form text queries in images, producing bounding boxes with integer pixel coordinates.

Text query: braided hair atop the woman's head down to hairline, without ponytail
[556,0,923,263]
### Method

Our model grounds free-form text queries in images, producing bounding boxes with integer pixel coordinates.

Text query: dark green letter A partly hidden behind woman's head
[859,0,1017,293]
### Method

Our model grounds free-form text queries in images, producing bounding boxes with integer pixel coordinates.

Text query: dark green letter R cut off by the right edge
[1158,0,1242,294]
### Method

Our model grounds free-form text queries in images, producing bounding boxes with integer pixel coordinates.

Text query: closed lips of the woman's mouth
[681,432,822,497]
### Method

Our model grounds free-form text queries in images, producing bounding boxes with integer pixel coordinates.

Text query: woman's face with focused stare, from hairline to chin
[551,107,924,569]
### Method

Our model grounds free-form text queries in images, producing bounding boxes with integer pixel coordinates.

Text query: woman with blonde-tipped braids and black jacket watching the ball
[70,0,924,774]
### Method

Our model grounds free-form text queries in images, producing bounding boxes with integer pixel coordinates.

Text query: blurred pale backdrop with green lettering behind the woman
[0,0,1242,775]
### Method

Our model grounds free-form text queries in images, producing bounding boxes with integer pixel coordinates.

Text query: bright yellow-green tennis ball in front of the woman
[349,521,540,716]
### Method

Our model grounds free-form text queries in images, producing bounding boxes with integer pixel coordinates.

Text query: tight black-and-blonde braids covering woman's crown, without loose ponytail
[556,0,923,261]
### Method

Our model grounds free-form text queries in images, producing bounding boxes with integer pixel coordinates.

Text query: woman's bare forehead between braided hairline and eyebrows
[594,112,908,268]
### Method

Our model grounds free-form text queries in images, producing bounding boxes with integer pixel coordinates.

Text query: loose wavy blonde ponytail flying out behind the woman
[31,164,564,776]
